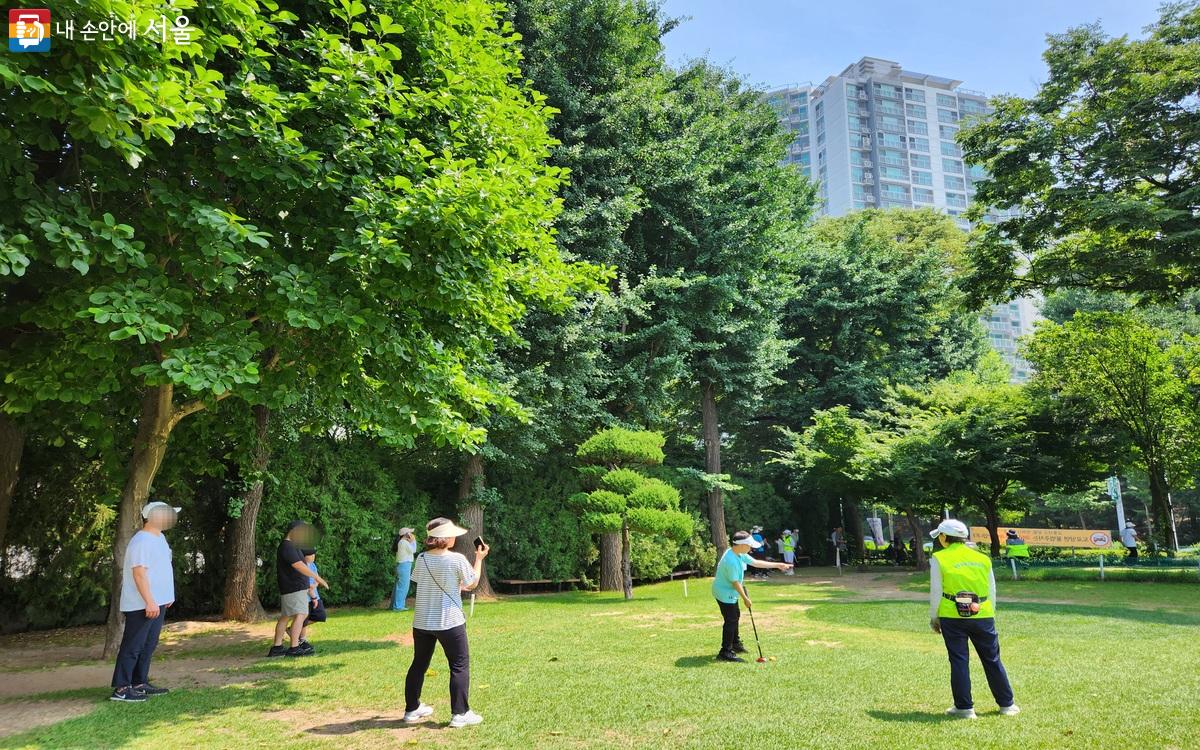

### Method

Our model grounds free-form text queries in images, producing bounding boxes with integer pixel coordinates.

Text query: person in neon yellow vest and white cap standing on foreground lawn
[929,518,1021,719]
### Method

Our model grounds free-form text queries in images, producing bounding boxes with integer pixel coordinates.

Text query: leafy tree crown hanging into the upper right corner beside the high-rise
[960,2,1200,301]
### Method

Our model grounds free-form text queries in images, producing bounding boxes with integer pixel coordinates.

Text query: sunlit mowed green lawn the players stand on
[0,571,1200,750]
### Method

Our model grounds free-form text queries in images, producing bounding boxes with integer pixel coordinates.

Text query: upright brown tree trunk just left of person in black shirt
[221,404,271,623]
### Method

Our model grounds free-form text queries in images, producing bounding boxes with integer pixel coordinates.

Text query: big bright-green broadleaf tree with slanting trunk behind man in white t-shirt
[2,0,600,641]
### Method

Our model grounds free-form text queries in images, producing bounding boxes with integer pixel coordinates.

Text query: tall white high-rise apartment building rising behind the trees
[767,58,1037,380]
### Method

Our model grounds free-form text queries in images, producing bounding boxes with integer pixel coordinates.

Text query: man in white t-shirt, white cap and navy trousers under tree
[109,503,179,703]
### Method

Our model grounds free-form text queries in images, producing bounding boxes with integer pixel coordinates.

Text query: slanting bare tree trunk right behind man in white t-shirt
[102,384,176,659]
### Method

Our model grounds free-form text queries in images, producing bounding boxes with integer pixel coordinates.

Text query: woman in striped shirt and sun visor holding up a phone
[404,518,488,728]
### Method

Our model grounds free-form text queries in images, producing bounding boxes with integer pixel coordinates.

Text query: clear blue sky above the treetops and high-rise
[666,0,1159,96]
